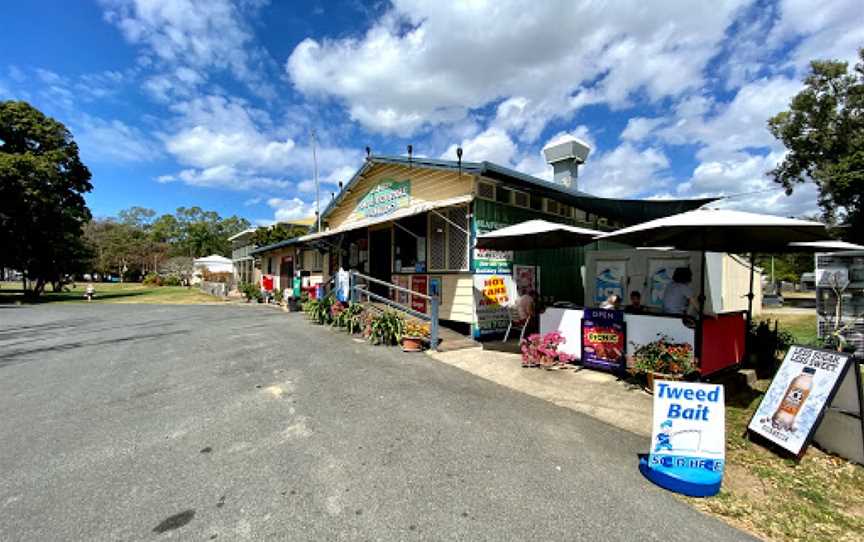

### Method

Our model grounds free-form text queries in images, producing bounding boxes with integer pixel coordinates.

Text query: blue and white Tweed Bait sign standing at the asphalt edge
[639,380,726,497]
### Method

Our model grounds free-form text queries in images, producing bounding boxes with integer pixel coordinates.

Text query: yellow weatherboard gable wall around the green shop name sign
[326,164,474,229]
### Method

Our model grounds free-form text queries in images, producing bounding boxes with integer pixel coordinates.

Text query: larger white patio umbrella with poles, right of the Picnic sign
[598,209,828,364]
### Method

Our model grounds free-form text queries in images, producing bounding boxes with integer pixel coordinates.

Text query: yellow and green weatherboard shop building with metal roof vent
[252,139,710,337]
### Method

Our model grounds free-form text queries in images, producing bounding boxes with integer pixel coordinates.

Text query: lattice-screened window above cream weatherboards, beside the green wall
[429,207,468,271]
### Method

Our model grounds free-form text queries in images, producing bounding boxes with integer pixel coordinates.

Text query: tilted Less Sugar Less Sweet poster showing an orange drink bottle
[747,345,851,457]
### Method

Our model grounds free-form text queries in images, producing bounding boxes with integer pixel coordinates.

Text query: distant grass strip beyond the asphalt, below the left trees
[0,282,223,305]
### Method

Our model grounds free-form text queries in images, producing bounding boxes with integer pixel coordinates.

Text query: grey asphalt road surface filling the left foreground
[0,304,747,541]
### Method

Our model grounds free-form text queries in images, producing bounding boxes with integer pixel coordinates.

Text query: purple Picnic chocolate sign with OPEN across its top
[582,309,627,372]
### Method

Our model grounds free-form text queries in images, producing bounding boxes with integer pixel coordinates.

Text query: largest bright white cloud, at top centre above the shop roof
[286,0,739,136]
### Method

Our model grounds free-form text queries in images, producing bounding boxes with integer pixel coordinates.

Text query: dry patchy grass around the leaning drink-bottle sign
[687,310,864,542]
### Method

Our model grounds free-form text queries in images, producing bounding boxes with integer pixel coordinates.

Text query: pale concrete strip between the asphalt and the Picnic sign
[426,347,653,438]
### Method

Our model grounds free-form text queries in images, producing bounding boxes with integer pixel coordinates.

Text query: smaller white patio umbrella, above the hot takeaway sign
[477,220,603,250]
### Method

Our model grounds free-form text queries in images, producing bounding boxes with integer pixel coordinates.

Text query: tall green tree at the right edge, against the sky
[768,48,864,243]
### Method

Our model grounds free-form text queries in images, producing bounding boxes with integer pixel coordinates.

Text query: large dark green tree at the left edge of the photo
[0,101,92,296]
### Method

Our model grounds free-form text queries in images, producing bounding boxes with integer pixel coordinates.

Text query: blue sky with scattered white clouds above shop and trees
[0,0,864,224]
